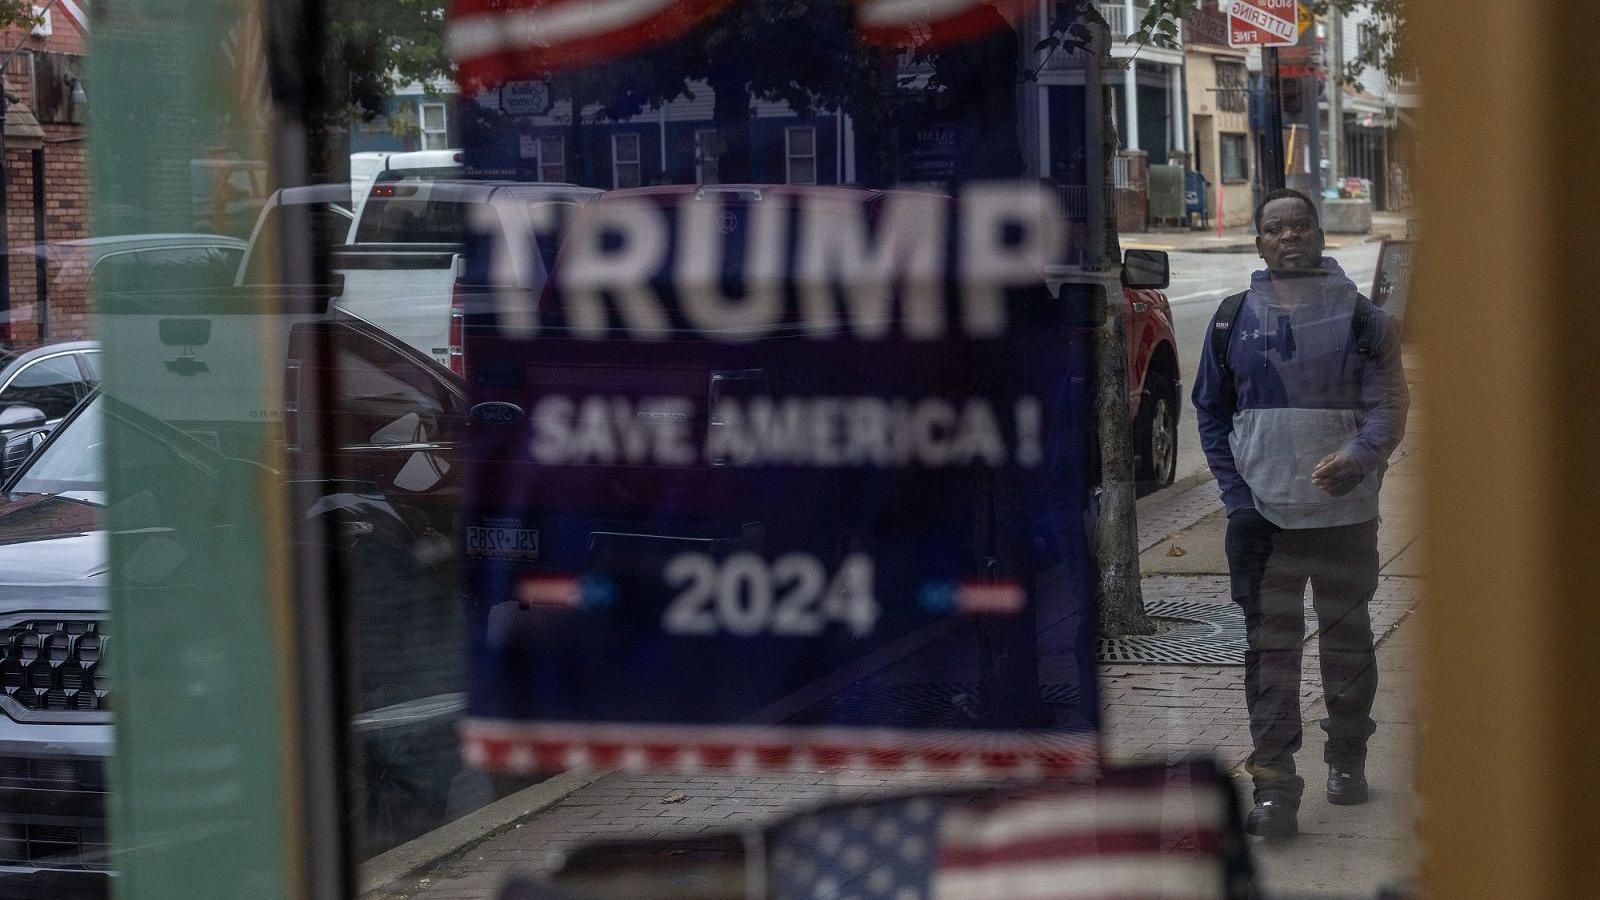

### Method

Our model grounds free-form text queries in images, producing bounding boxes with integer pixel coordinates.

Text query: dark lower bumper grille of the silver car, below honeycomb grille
[0,756,110,870]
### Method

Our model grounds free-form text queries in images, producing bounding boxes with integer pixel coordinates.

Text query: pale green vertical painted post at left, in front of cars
[86,0,306,900]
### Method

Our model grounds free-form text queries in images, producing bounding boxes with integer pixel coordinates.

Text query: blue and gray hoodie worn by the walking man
[1194,256,1410,528]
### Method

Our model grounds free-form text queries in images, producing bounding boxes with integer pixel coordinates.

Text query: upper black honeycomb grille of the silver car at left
[0,618,109,713]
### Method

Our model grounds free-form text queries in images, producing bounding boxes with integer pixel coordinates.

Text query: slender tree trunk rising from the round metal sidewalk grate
[1085,17,1155,637]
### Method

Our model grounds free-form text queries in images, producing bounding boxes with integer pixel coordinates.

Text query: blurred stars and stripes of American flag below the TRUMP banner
[768,764,1250,900]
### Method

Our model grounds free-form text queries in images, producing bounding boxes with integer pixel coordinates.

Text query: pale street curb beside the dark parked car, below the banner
[357,759,611,897]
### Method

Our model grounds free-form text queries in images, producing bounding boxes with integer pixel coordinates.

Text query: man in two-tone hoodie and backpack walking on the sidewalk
[1194,191,1408,838]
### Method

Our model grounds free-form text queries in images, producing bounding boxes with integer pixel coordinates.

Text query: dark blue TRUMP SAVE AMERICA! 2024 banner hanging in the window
[448,2,1102,773]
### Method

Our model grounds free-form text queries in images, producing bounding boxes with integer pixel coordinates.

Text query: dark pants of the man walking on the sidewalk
[1227,509,1378,802]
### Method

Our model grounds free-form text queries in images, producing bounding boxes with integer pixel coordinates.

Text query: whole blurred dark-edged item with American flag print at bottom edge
[524,761,1251,900]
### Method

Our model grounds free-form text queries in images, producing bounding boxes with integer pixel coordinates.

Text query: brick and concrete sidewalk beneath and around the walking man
[368,447,1421,900]
